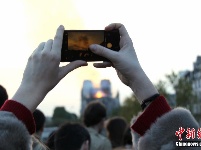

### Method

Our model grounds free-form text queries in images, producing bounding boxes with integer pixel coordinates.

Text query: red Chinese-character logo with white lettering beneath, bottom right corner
[175,127,201,147]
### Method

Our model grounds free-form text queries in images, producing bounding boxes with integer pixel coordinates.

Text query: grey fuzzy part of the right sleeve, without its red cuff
[138,107,199,150]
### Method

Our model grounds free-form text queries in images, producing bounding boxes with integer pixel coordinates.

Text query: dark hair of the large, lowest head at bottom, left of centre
[54,123,91,150]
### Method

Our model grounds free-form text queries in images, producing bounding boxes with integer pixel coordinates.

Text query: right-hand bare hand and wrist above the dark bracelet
[90,23,158,103]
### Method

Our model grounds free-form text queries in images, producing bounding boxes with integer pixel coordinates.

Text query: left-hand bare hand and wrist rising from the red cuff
[13,26,87,111]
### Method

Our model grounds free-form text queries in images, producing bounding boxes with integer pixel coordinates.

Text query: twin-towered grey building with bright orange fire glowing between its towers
[80,80,120,115]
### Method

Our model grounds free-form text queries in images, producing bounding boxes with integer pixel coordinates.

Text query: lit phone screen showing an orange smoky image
[67,31,104,50]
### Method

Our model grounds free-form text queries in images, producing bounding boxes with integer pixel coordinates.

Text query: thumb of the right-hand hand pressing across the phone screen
[89,44,118,62]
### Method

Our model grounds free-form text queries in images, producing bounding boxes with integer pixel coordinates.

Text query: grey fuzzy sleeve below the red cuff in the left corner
[0,111,31,149]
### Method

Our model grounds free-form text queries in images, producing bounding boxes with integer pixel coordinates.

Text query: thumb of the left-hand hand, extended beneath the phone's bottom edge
[59,60,88,80]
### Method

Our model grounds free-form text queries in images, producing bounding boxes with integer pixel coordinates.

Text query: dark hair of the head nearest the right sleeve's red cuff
[106,117,127,148]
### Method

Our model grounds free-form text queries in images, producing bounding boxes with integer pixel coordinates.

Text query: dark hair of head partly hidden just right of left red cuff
[33,109,45,132]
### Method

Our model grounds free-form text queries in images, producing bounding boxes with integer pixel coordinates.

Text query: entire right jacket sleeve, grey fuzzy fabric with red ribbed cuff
[132,96,201,150]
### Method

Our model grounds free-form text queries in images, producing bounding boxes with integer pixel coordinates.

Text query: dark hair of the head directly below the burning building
[83,101,106,127]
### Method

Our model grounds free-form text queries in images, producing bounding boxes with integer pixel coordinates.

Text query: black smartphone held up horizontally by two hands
[61,29,120,62]
